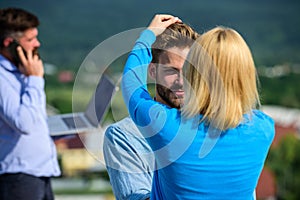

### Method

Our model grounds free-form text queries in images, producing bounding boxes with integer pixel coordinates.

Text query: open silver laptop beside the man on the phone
[48,75,117,136]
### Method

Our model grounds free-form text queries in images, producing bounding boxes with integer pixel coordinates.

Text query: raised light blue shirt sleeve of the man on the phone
[0,74,46,134]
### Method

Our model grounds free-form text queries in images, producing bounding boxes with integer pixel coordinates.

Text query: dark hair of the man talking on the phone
[0,8,40,47]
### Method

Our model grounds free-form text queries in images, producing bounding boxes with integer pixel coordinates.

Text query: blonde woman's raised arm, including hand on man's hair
[122,15,181,126]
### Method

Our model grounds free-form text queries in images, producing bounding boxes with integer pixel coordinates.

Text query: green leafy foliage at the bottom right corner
[266,134,300,200]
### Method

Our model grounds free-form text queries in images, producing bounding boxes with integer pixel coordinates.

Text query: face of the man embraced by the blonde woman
[151,47,189,108]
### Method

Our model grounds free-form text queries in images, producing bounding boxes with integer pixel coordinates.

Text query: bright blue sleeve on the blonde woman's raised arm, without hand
[121,30,181,150]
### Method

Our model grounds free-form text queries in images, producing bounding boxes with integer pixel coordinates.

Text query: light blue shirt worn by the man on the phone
[0,55,60,177]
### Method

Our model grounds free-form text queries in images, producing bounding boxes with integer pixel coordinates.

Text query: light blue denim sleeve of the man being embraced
[103,119,154,200]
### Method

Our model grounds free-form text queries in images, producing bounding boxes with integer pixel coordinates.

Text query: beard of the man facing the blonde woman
[156,84,184,109]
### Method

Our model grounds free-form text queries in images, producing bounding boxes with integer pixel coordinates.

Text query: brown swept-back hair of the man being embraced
[151,23,199,63]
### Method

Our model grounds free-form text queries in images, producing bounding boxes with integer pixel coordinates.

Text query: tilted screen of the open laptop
[84,74,116,126]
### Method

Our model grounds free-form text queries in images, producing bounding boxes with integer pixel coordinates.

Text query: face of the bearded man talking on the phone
[18,28,41,51]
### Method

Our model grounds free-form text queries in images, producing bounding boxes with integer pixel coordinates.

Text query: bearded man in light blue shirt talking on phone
[0,8,60,200]
